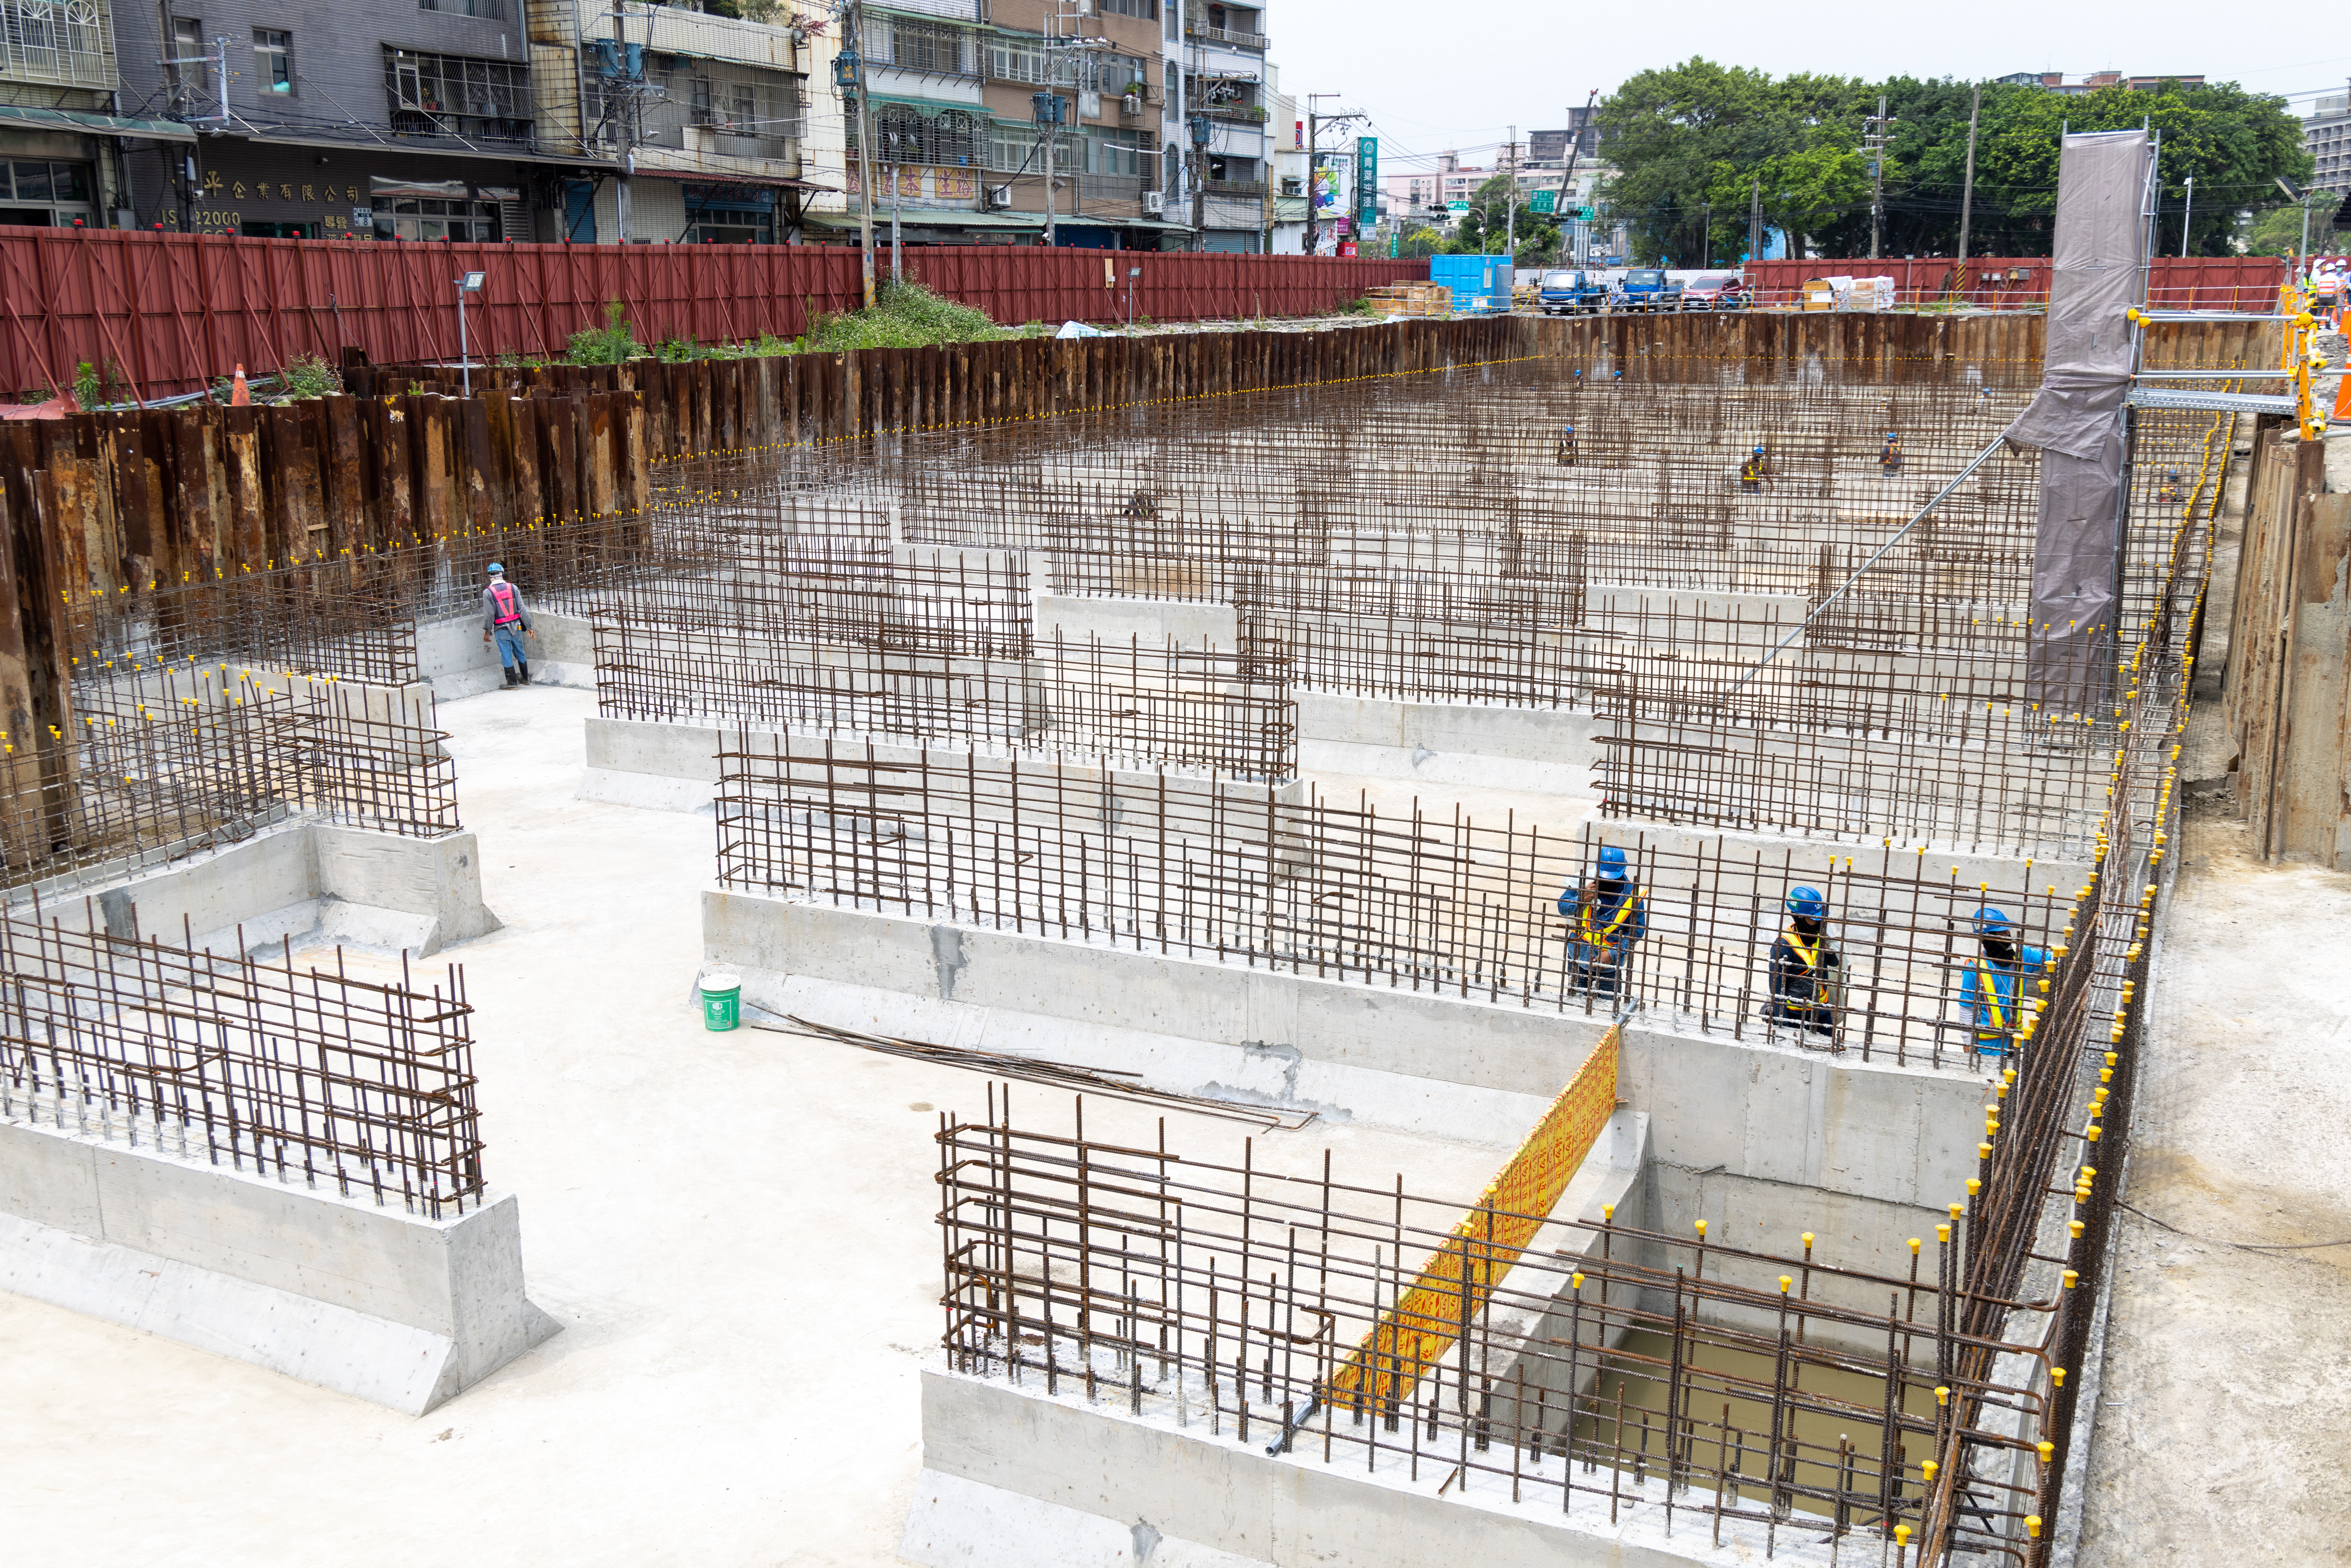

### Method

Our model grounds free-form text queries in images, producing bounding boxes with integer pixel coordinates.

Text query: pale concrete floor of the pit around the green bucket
[0,689,1516,1566]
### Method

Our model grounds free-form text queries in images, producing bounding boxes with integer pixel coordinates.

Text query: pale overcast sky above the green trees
[1265,0,2351,174]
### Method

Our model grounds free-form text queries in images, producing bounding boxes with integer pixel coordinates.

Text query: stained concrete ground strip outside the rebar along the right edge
[2078,818,2351,1568]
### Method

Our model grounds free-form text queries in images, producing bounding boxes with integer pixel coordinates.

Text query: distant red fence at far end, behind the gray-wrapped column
[1740,256,2287,311]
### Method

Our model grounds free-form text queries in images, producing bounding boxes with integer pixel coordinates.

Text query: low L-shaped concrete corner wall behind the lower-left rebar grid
[19,820,498,957]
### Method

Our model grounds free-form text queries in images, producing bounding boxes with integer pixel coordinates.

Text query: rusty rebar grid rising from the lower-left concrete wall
[0,910,482,1220]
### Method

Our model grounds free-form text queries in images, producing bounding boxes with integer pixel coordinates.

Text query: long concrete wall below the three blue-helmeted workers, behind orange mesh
[703,891,1987,1272]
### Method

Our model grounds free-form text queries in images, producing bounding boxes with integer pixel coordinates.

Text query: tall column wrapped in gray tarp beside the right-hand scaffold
[2005,131,2147,712]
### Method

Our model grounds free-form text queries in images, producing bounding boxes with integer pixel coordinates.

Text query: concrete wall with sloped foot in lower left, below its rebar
[0,1098,557,1415]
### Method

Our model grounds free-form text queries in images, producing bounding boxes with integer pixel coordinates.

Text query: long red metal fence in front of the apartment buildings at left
[0,228,1429,399]
